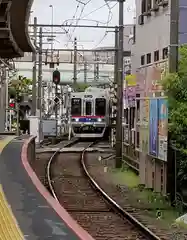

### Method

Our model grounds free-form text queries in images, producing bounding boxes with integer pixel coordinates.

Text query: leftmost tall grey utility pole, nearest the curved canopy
[31,17,37,116]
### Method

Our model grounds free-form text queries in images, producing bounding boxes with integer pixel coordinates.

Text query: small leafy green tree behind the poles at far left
[9,76,32,97]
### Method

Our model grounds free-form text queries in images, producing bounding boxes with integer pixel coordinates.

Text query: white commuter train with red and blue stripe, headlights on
[71,87,110,138]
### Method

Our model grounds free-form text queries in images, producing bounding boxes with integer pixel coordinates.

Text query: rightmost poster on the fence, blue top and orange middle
[158,99,168,161]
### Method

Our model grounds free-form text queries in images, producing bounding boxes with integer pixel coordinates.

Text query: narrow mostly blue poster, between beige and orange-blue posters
[149,99,158,157]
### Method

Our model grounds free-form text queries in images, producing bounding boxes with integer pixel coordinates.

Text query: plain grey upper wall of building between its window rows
[132,0,170,73]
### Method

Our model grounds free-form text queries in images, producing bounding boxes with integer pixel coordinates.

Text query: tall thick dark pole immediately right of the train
[116,0,124,168]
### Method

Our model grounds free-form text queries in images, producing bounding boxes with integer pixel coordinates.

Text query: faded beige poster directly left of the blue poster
[139,99,149,153]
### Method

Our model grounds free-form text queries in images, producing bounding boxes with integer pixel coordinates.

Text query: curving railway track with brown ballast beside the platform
[47,141,160,240]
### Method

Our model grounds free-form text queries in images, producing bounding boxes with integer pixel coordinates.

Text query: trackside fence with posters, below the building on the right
[123,97,168,192]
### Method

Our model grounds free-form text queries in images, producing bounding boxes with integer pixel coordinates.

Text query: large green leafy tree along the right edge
[163,45,187,183]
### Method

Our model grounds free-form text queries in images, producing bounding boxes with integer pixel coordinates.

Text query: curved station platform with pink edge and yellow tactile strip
[0,136,93,240]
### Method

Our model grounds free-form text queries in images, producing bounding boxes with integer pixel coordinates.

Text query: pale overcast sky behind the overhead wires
[30,0,135,49]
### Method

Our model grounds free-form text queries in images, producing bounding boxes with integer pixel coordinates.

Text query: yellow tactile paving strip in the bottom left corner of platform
[0,185,24,240]
